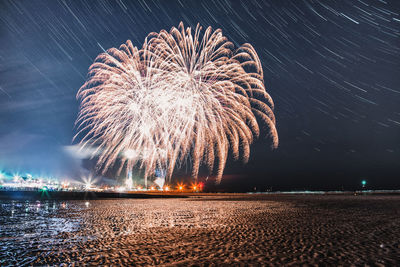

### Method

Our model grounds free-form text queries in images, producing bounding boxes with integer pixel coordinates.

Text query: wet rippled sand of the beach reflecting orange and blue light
[0,195,400,266]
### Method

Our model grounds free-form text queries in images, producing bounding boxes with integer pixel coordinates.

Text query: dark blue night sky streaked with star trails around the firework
[0,0,400,191]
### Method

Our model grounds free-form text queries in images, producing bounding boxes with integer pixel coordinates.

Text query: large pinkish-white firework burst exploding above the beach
[77,23,278,184]
